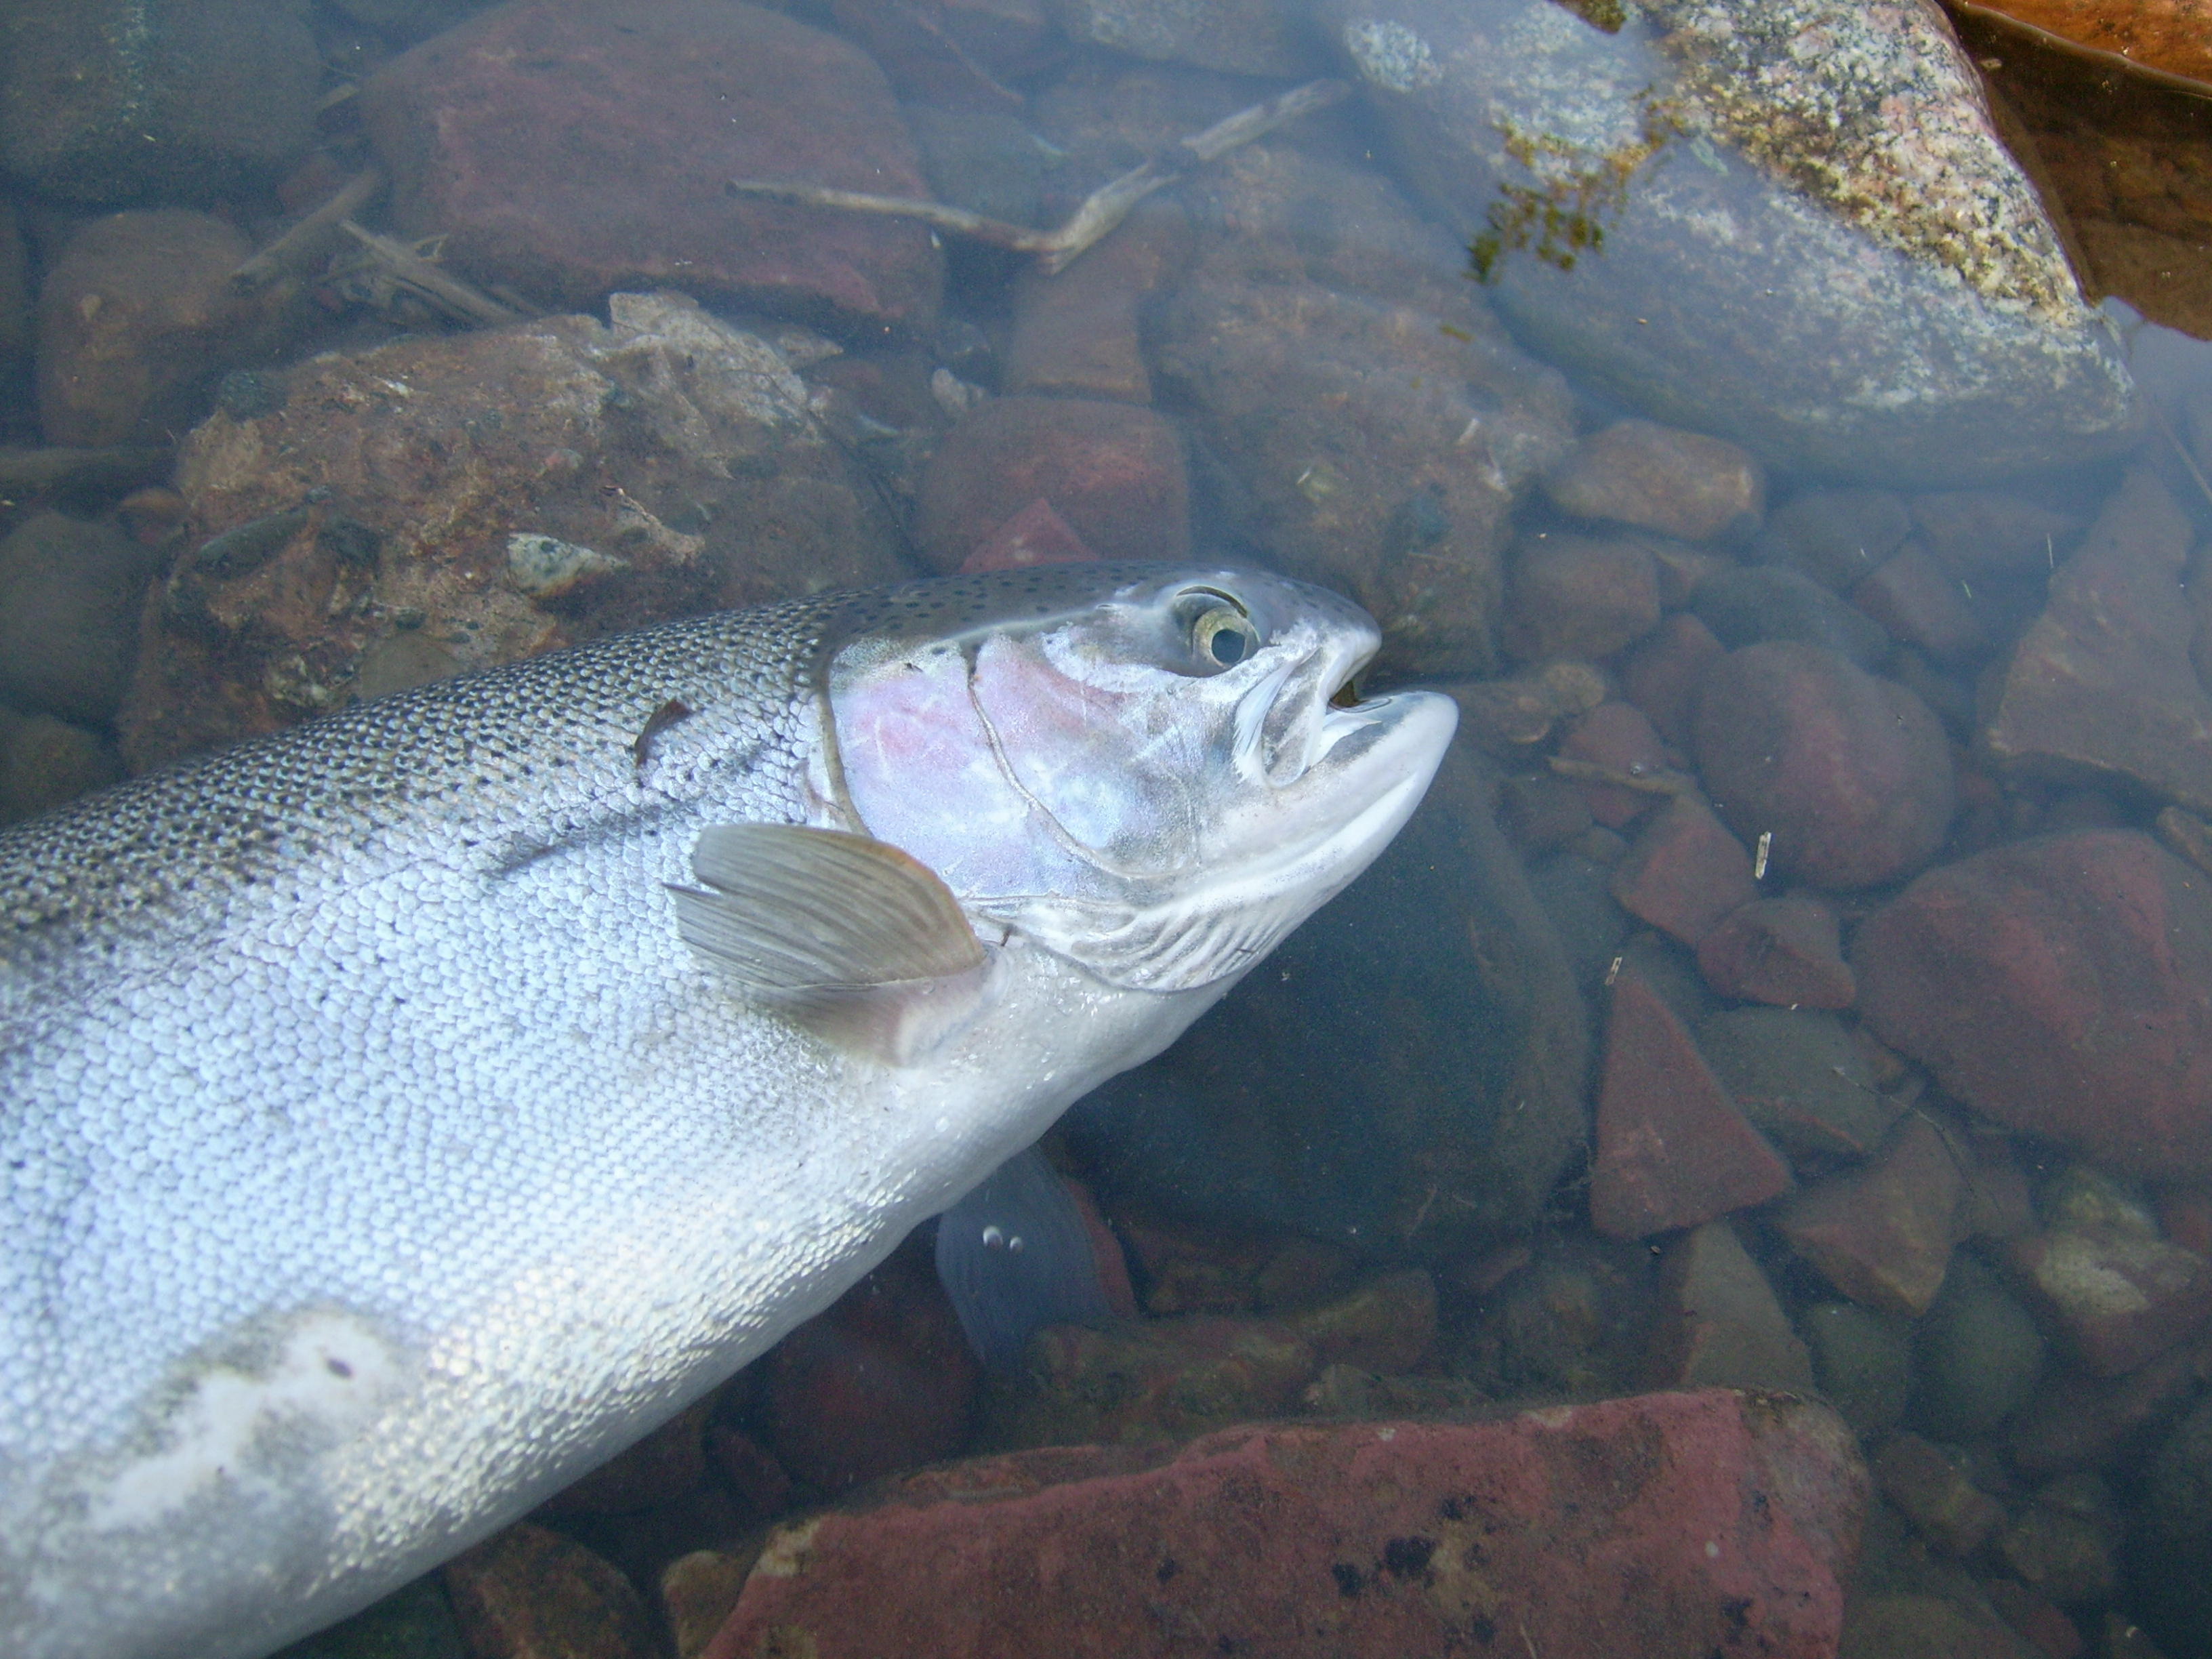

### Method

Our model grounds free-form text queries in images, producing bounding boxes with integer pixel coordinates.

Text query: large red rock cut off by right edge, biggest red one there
[1851,830,2212,1179]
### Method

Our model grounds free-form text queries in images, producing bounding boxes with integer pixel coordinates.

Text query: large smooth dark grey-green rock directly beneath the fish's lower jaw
[1066,725,1589,1258]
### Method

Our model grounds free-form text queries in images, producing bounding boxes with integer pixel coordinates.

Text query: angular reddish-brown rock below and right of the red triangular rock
[1776,1113,1962,1318]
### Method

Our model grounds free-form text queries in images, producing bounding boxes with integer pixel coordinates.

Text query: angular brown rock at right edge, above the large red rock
[1982,471,2212,812]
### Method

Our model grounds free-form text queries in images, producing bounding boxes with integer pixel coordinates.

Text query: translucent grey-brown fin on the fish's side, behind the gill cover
[670,823,991,1066]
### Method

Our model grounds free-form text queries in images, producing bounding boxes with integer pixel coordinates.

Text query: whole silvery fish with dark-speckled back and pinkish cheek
[0,567,1451,1659]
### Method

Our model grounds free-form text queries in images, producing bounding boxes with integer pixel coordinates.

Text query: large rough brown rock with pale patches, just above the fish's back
[117,294,912,768]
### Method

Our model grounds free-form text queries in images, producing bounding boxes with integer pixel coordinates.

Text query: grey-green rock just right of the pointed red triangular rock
[1696,1008,1898,1159]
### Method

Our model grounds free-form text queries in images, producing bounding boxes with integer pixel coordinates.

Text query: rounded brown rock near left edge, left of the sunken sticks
[37,208,287,445]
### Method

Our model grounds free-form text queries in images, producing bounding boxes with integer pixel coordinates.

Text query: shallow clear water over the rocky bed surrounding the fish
[0,0,2212,1659]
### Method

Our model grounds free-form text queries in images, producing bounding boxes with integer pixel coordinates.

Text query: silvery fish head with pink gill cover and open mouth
[821,564,1458,991]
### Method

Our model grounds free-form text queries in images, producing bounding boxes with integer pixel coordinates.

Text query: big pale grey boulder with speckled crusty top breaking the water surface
[1321,0,2142,483]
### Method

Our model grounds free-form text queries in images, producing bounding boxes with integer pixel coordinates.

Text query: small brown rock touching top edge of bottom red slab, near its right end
[1645,1221,1814,1389]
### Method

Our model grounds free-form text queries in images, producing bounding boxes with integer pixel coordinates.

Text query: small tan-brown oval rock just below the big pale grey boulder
[1544,420,1767,542]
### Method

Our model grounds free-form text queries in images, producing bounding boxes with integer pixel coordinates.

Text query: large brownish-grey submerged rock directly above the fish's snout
[1157,133,1573,672]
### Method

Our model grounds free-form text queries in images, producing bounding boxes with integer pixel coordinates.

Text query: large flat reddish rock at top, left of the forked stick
[361,0,942,329]
